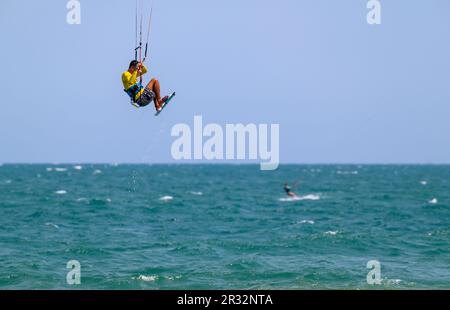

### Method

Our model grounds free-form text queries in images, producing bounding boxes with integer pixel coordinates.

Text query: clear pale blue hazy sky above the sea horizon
[0,0,450,163]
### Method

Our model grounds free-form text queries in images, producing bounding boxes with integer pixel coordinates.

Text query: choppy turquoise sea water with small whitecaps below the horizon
[0,165,450,289]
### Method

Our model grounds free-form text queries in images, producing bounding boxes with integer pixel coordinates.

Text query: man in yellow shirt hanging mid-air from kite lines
[122,60,168,112]
